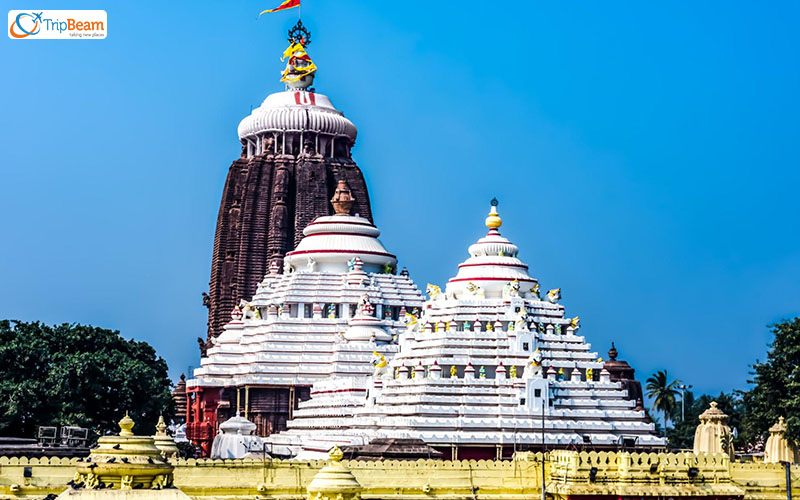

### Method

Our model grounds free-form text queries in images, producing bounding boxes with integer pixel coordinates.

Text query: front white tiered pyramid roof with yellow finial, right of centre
[269,202,665,458]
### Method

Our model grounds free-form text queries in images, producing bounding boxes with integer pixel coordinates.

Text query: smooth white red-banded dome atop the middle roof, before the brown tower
[284,215,397,272]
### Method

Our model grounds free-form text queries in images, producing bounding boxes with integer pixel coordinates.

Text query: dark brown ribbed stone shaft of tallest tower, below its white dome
[204,149,372,348]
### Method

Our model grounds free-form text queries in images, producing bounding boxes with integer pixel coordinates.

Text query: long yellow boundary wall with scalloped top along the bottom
[0,451,800,500]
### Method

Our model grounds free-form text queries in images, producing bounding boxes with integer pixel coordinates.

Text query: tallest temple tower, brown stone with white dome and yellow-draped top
[203,22,372,346]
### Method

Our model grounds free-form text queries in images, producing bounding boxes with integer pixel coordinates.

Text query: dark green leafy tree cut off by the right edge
[741,318,800,445]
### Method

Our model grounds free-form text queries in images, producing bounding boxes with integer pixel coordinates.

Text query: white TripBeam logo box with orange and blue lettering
[8,10,108,40]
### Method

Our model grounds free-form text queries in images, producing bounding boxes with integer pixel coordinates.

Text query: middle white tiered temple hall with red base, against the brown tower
[186,186,423,453]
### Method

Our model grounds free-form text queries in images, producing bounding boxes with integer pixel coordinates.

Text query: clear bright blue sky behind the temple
[0,0,800,393]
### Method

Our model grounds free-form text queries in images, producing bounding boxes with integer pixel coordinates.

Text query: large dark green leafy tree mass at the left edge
[0,320,174,436]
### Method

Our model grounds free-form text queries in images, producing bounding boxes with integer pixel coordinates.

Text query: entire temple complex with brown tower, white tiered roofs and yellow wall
[0,12,800,500]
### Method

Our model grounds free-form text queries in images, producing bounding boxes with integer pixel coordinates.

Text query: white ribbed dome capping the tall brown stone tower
[239,90,357,142]
